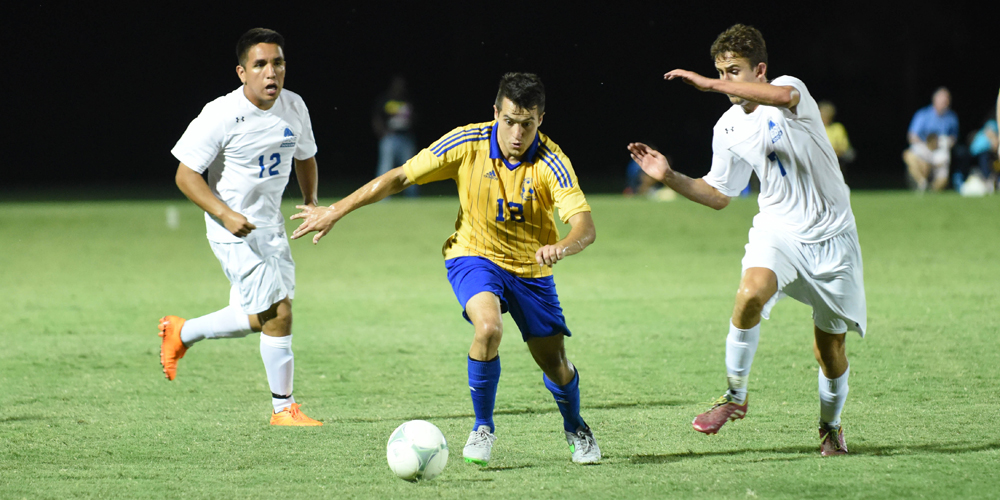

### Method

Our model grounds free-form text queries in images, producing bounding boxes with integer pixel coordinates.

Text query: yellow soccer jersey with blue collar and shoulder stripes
[403,121,590,278]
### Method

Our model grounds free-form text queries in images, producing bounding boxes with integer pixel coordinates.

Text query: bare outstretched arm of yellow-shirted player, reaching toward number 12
[291,167,412,244]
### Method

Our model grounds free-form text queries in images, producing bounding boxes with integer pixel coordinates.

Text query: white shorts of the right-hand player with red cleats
[743,228,868,337]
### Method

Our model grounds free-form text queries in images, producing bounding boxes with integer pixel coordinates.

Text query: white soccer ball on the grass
[385,420,448,482]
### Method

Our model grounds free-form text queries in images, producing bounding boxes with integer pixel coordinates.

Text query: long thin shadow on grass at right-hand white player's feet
[629,442,1000,464]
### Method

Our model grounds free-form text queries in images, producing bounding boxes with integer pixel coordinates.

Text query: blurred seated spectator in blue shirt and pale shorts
[903,87,958,191]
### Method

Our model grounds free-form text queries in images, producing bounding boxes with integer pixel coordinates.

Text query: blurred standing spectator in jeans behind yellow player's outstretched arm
[372,75,418,196]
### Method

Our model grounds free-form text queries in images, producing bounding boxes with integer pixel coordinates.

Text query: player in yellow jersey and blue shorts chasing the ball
[292,73,601,465]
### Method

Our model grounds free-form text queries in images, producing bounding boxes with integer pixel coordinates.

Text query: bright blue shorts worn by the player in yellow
[444,257,570,342]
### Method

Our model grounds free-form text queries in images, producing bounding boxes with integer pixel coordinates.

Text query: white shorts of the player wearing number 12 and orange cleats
[209,228,295,314]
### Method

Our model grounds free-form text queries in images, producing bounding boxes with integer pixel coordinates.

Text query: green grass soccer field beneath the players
[0,193,1000,499]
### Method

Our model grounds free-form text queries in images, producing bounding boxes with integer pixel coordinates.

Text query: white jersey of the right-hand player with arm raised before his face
[704,76,855,243]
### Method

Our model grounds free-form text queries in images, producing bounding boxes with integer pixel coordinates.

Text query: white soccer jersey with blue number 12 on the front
[170,87,316,243]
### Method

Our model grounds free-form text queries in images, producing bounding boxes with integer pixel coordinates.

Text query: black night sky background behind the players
[0,1,1000,198]
